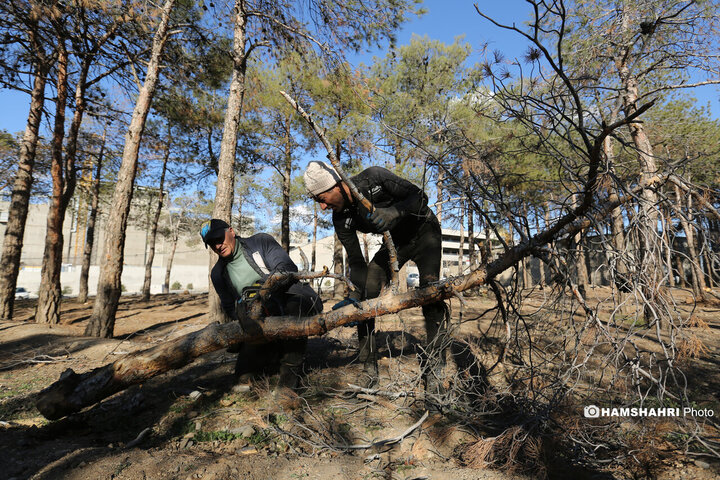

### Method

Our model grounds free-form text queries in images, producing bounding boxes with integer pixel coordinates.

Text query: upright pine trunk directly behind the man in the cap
[208,0,247,322]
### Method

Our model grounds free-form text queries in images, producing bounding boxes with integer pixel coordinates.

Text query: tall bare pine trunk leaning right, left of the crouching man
[85,0,175,338]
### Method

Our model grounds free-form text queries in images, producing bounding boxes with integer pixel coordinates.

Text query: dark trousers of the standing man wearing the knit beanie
[358,216,447,376]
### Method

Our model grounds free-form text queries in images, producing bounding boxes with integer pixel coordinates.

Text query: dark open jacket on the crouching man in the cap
[210,233,322,319]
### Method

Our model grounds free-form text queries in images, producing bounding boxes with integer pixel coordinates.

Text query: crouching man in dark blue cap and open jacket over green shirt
[200,218,322,396]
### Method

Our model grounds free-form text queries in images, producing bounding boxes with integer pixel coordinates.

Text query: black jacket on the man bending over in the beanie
[333,167,437,296]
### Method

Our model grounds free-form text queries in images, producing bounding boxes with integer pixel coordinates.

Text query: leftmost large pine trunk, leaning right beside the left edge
[0,62,48,320]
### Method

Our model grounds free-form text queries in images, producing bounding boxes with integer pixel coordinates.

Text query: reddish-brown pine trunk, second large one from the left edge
[35,38,68,324]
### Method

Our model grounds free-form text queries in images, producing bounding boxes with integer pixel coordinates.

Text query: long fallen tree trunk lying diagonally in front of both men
[37,177,661,420]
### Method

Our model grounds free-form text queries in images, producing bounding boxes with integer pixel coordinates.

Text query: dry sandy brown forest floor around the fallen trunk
[0,289,720,480]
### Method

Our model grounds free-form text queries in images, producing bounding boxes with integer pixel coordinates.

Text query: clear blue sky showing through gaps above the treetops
[0,0,720,133]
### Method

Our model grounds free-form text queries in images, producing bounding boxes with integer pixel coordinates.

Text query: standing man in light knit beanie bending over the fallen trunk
[304,161,447,407]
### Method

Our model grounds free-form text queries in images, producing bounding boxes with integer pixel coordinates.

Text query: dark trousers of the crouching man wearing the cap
[235,285,323,377]
